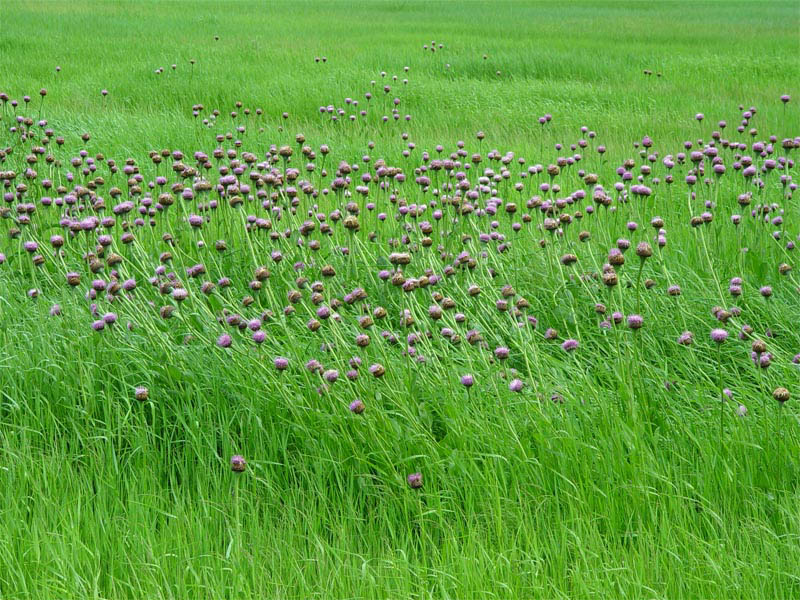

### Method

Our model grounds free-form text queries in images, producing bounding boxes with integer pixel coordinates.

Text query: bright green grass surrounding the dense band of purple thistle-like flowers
[0,0,800,599]
